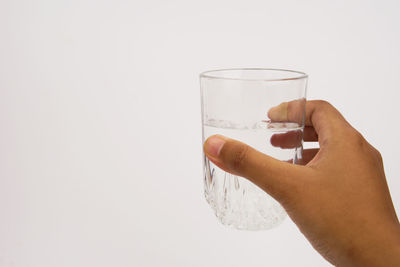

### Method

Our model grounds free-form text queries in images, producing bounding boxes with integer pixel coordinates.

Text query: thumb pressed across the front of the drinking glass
[204,135,305,200]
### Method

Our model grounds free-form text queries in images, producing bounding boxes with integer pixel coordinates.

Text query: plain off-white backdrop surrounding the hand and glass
[0,0,400,267]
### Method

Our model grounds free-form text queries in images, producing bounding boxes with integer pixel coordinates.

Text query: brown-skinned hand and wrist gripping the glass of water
[204,101,400,267]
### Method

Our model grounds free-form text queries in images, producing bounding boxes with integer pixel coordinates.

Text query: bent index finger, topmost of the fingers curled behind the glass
[268,99,348,147]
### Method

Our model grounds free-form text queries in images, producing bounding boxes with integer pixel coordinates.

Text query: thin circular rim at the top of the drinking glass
[200,68,308,82]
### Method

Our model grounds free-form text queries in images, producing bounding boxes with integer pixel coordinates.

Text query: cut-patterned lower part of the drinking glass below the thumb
[205,162,287,231]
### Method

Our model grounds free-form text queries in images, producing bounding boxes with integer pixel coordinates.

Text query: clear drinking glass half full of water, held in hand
[200,69,307,230]
